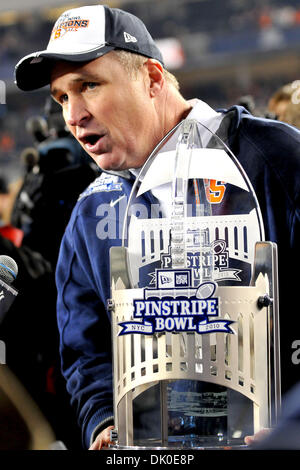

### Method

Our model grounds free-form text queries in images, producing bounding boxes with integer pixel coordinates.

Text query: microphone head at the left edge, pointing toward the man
[0,255,18,323]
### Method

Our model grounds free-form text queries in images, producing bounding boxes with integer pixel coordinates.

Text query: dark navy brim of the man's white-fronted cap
[15,46,115,91]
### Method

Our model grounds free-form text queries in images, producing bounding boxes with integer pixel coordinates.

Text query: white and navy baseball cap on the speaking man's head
[15,5,164,91]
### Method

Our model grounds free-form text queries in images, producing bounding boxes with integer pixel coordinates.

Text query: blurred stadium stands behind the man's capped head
[0,0,300,207]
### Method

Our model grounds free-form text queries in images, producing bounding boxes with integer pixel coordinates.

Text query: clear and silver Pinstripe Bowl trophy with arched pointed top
[109,119,280,449]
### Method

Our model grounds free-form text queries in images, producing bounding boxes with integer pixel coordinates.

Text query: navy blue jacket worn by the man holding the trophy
[56,107,300,447]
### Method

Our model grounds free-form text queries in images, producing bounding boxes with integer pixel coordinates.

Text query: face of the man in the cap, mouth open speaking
[51,53,163,170]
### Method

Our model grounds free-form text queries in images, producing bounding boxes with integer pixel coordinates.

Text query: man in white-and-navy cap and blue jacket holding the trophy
[16,5,300,449]
